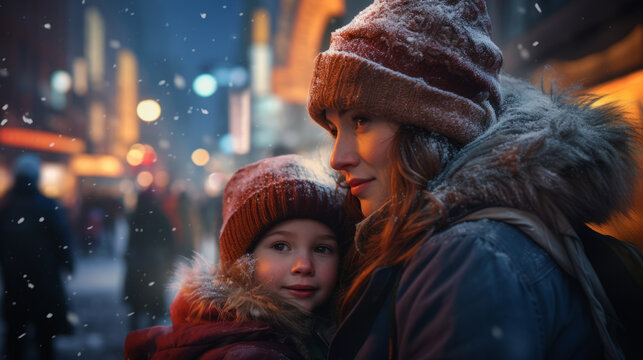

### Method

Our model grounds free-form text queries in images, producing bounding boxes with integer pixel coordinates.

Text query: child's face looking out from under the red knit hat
[253,219,339,311]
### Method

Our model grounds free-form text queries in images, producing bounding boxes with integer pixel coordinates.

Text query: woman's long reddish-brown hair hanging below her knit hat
[338,125,458,319]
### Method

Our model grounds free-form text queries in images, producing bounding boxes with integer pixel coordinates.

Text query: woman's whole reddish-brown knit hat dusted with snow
[308,0,502,144]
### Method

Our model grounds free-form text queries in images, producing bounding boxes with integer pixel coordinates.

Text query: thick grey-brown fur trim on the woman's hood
[428,76,638,226]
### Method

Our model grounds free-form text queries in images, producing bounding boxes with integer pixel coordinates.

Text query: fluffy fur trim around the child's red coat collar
[170,255,312,336]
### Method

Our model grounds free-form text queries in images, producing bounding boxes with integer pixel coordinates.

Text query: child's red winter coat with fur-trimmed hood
[125,263,326,360]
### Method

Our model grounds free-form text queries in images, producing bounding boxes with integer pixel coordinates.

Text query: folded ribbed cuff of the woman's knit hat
[308,50,495,144]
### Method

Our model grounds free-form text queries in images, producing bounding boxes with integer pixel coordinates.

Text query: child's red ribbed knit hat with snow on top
[219,155,344,267]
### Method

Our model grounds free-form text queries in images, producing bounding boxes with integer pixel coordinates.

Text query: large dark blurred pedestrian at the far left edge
[0,154,73,359]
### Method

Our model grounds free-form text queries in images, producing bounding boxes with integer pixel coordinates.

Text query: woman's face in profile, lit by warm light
[326,109,399,216]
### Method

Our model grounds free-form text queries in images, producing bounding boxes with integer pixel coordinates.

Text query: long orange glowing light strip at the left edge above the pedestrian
[0,127,85,154]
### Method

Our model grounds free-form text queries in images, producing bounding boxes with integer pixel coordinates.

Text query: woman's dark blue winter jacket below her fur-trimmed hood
[329,219,603,360]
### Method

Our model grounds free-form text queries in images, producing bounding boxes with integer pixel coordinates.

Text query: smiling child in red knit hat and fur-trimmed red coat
[125,155,346,359]
